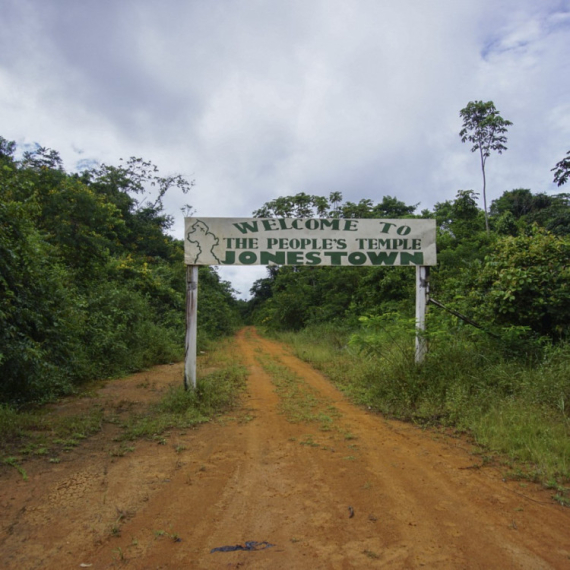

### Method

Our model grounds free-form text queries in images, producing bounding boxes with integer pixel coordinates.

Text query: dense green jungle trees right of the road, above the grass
[249,189,570,339]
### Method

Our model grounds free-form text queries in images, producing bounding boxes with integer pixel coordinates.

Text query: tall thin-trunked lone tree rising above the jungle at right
[459,101,512,233]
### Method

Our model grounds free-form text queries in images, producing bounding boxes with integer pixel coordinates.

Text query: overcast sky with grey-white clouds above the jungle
[0,0,570,295]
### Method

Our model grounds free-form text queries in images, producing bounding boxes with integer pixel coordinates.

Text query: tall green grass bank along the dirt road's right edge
[266,319,570,504]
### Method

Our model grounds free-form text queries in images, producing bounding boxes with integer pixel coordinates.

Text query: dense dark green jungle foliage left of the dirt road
[0,137,239,404]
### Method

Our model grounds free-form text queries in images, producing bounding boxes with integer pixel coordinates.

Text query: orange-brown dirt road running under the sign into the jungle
[0,330,570,570]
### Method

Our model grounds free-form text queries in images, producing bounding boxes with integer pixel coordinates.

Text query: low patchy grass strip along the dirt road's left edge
[0,339,247,477]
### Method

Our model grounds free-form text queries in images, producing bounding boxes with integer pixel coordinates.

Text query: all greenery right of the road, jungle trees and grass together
[248,189,570,484]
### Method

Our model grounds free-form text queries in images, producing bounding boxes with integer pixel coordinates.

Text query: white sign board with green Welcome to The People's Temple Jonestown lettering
[184,218,436,266]
